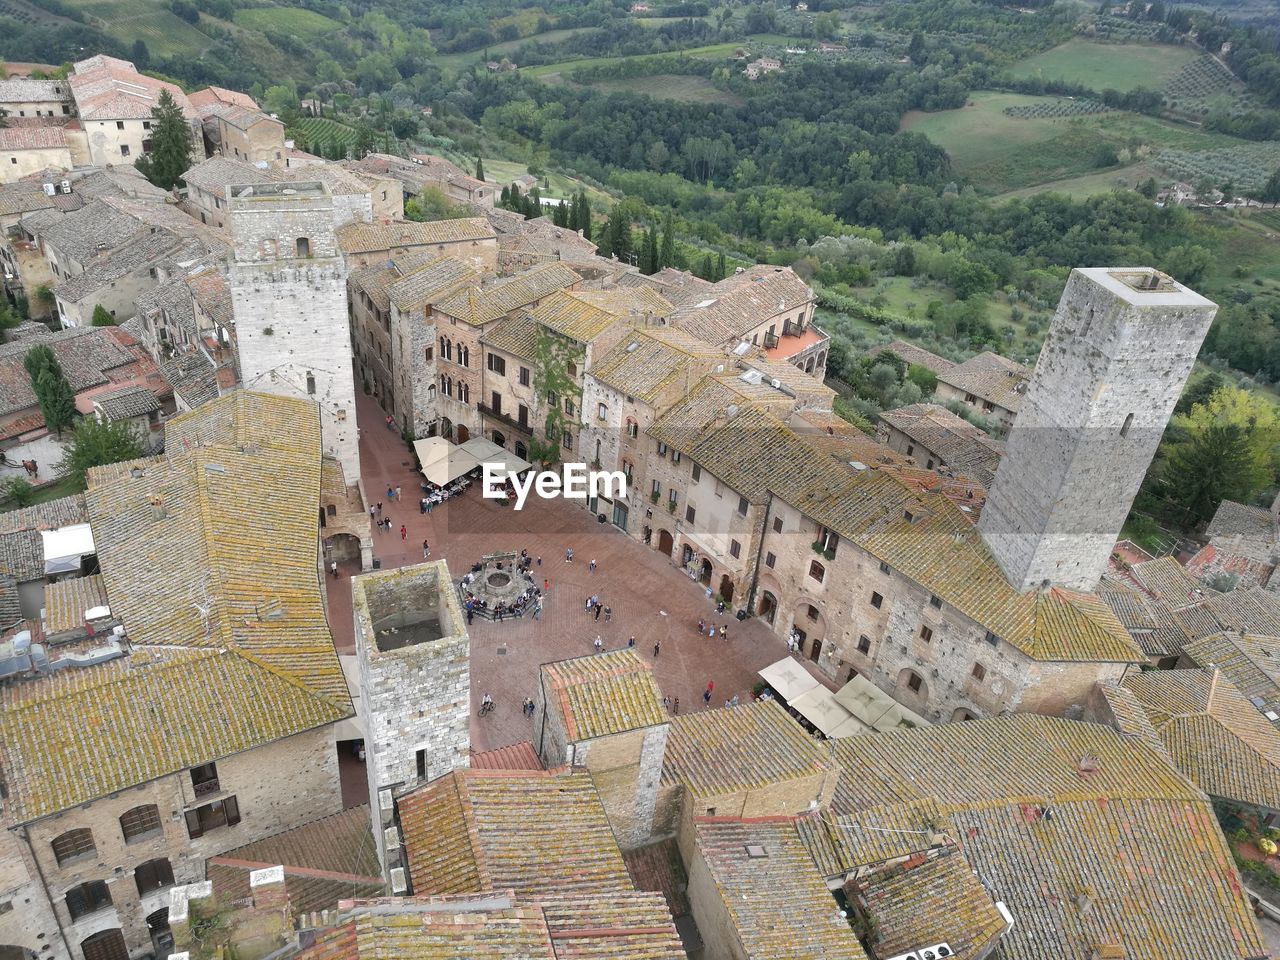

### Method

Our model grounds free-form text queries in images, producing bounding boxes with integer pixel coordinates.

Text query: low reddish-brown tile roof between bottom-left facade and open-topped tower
[205,804,384,915]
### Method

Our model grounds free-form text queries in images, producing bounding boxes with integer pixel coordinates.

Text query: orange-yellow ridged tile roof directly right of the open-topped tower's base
[398,771,631,899]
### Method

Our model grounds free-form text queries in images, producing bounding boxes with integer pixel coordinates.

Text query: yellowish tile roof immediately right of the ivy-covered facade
[588,326,726,404]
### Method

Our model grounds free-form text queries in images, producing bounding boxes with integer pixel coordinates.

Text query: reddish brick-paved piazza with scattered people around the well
[328,396,786,751]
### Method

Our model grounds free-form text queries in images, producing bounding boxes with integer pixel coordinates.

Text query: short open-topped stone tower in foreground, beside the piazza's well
[352,561,471,863]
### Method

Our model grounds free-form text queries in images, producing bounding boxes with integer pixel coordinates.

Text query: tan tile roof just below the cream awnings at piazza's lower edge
[662,700,831,796]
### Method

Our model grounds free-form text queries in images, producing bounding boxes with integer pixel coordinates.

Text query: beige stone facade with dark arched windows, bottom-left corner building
[10,726,342,959]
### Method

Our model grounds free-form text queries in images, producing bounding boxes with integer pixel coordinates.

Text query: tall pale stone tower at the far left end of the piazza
[227,182,360,485]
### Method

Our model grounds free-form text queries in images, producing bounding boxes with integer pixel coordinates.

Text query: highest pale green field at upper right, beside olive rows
[1011,40,1199,91]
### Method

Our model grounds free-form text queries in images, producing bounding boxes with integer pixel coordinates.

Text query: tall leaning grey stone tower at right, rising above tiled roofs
[978,268,1217,590]
